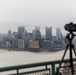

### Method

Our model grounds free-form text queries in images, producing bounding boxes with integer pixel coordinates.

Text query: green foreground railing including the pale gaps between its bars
[0,58,76,75]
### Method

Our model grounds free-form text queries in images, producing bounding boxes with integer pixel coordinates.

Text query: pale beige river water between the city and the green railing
[0,50,75,75]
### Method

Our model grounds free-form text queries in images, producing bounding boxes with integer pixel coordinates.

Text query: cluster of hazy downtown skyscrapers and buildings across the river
[4,26,65,49]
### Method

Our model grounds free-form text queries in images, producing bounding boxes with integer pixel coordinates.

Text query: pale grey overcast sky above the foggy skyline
[0,0,76,34]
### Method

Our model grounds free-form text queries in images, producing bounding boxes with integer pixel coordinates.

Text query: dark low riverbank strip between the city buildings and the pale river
[0,46,65,52]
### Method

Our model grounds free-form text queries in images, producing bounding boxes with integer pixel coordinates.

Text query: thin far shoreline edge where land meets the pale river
[0,48,65,53]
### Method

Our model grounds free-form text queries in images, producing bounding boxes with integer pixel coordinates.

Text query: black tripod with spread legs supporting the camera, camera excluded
[55,32,76,75]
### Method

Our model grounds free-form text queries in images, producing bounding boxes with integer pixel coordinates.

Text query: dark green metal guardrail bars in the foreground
[0,58,76,75]
